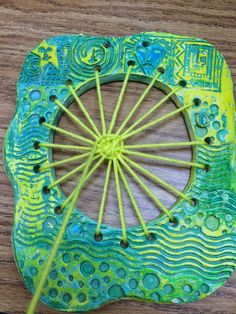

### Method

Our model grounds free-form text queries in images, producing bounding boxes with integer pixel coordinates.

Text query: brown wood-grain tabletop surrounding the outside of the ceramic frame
[0,0,236,314]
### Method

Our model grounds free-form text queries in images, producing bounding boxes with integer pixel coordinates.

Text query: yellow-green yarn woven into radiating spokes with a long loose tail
[27,65,205,314]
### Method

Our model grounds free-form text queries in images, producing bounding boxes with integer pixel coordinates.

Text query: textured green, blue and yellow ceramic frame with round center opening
[4,33,236,312]
